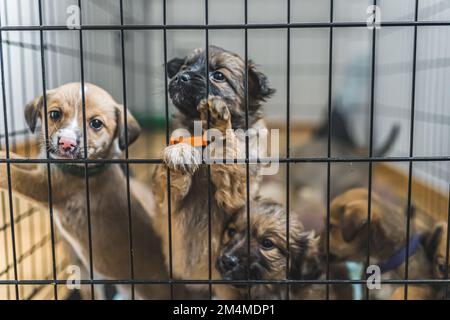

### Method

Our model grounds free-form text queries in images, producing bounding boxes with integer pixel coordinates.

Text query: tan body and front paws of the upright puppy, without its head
[154,97,246,296]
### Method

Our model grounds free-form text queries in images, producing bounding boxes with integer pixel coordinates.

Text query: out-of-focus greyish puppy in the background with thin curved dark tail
[260,107,399,232]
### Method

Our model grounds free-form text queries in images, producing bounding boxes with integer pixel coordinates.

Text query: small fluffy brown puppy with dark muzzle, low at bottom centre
[216,198,351,300]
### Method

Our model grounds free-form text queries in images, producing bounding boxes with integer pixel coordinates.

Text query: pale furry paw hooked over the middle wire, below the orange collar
[163,143,202,174]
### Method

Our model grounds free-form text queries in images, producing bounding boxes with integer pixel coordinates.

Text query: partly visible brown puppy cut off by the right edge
[424,222,450,299]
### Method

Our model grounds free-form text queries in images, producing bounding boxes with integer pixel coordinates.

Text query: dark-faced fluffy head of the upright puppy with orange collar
[167,46,275,129]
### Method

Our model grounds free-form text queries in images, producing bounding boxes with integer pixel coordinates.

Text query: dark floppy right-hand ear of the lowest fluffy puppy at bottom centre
[289,231,322,280]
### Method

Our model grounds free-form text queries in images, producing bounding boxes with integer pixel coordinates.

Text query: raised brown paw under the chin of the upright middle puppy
[197,96,231,133]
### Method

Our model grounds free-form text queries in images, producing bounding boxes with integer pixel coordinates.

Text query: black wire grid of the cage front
[0,0,450,300]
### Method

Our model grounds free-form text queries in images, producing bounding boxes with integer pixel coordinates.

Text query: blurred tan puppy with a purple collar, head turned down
[322,189,433,299]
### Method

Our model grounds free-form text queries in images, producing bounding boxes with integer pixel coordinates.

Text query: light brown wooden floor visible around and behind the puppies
[0,126,448,300]
